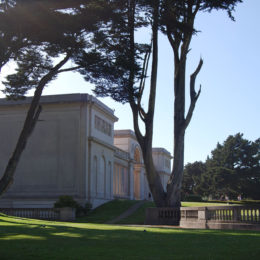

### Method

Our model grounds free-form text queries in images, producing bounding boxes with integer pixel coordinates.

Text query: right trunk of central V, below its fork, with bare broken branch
[166,57,203,207]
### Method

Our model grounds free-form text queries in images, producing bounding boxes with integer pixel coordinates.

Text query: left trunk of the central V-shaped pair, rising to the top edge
[129,0,165,207]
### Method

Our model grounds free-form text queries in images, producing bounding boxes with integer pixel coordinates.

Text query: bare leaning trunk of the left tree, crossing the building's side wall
[0,54,70,196]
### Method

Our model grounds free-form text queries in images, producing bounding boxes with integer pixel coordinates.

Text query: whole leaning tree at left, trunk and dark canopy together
[0,0,115,195]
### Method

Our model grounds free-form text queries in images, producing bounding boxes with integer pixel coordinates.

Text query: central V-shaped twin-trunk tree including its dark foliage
[82,0,242,207]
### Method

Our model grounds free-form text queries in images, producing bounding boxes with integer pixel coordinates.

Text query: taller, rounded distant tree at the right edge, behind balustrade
[206,134,260,199]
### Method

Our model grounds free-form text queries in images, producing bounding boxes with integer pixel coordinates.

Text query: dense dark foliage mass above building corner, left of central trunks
[76,0,150,103]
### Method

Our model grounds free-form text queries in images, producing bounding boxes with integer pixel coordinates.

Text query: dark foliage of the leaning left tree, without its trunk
[0,0,111,99]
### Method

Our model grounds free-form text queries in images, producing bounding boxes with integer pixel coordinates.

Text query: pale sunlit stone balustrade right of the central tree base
[180,205,260,230]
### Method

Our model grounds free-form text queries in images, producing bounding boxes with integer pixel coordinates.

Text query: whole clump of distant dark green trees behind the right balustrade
[183,133,260,200]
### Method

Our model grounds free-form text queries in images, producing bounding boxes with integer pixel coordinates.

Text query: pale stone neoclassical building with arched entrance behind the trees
[0,94,172,208]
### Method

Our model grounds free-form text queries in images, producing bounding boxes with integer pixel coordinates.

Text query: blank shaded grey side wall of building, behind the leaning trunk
[0,103,85,207]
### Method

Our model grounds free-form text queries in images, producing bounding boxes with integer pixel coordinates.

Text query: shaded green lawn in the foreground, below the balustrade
[0,215,260,260]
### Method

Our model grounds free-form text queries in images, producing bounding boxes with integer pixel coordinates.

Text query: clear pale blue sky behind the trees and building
[0,0,260,163]
